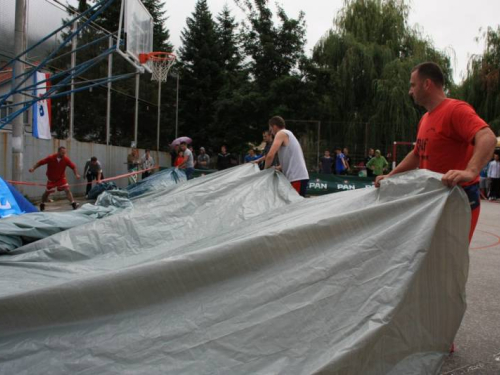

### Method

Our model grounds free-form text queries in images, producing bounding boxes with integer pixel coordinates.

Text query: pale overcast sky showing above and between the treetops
[165,0,500,82]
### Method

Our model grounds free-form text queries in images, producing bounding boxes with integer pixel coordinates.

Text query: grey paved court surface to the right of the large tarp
[441,201,500,375]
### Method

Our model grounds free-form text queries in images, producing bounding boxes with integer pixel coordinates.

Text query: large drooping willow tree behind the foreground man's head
[312,0,452,151]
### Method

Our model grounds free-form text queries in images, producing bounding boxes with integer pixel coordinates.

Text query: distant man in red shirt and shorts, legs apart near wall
[29,146,80,211]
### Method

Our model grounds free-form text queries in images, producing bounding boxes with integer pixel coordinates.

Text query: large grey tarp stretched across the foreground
[0,165,470,375]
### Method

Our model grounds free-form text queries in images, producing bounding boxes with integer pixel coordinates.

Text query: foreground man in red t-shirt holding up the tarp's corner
[375,62,497,241]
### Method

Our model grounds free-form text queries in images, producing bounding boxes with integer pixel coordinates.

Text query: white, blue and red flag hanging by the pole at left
[33,72,52,139]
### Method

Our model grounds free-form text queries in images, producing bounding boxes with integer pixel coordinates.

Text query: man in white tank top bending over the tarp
[264,116,309,197]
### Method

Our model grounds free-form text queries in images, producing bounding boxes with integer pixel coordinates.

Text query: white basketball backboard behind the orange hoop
[123,0,153,71]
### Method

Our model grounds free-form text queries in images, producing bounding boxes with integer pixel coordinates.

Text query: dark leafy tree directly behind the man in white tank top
[228,0,312,151]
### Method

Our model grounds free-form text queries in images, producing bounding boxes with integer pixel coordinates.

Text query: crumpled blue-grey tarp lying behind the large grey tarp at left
[0,168,186,254]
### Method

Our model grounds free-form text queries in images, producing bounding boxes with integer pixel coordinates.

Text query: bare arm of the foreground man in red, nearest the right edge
[441,128,497,187]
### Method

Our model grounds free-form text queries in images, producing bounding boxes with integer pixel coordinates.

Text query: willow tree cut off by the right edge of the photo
[458,27,500,134]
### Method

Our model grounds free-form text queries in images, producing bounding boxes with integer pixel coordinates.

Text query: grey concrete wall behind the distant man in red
[0,131,171,203]
